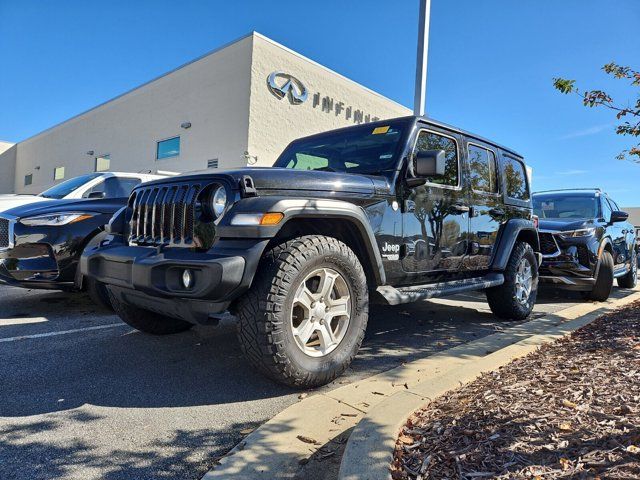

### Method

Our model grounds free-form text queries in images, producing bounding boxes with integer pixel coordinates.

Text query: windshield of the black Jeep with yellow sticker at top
[273,123,405,174]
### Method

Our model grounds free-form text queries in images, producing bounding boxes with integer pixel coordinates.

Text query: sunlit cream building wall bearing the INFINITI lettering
[249,34,411,166]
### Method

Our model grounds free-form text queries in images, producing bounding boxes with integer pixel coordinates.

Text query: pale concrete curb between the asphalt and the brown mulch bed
[203,286,640,480]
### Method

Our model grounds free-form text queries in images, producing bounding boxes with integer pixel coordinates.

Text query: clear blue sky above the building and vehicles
[0,0,640,206]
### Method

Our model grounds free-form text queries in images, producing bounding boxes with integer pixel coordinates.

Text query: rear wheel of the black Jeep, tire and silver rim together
[486,242,538,320]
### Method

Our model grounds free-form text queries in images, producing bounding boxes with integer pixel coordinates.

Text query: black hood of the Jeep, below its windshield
[139,167,389,194]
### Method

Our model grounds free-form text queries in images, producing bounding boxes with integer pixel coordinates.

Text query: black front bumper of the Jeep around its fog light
[80,240,268,323]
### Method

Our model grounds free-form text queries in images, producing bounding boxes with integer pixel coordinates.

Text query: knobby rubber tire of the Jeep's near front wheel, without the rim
[235,235,369,388]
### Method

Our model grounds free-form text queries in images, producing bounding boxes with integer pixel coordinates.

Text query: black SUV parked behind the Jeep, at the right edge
[533,188,638,301]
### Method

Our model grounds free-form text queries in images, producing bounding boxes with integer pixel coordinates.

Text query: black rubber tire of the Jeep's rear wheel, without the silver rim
[486,242,538,320]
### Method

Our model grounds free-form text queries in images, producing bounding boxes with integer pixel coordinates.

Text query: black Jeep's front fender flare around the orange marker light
[216,196,386,285]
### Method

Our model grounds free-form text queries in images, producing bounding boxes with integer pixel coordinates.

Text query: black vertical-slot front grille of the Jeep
[129,184,201,246]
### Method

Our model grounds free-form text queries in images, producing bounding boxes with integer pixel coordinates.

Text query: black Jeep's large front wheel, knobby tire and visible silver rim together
[236,235,369,388]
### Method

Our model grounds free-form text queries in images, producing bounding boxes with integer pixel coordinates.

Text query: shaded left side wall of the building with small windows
[12,36,252,193]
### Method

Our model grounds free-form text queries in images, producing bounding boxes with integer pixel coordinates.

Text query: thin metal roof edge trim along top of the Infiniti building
[18,30,409,143]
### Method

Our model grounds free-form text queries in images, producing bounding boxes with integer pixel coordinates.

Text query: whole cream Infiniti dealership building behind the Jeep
[0,32,411,193]
